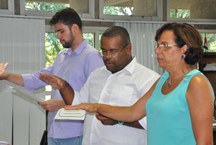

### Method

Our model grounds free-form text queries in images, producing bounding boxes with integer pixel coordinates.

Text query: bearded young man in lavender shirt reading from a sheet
[0,8,104,145]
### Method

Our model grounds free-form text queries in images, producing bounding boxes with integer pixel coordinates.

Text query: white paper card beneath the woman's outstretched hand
[55,108,86,120]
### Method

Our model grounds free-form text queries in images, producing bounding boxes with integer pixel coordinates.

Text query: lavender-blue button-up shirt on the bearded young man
[23,40,104,139]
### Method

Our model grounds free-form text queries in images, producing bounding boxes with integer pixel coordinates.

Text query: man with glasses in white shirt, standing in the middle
[41,26,159,145]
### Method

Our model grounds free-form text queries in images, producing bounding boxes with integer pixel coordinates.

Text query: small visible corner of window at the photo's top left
[0,0,14,14]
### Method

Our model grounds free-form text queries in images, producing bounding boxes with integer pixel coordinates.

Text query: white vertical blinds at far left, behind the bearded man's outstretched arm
[0,17,45,145]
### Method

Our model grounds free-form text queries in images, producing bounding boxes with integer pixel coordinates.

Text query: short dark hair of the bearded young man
[49,8,82,31]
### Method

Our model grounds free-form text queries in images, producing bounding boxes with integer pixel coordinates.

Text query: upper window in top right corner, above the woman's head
[167,0,216,21]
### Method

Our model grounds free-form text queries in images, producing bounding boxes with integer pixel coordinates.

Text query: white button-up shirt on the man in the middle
[73,58,159,145]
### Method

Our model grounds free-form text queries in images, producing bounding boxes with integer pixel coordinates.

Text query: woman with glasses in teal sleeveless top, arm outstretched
[65,23,214,145]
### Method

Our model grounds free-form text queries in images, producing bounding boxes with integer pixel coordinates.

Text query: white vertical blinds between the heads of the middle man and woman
[115,22,163,74]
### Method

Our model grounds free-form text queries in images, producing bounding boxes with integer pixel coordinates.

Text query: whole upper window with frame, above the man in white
[99,0,162,20]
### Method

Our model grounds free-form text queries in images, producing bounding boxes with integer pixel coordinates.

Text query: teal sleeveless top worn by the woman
[146,70,202,145]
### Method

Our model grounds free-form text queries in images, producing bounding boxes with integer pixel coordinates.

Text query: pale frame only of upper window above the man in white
[99,0,163,21]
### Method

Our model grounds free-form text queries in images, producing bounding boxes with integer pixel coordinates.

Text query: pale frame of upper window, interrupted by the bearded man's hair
[20,0,95,18]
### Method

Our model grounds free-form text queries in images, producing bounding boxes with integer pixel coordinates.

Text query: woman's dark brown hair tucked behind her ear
[155,23,203,65]
